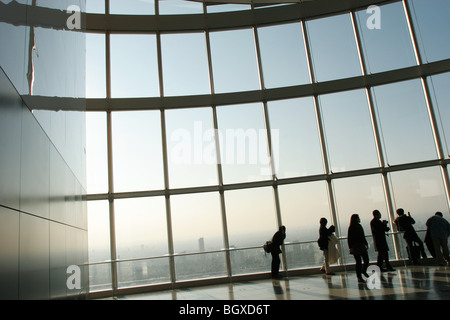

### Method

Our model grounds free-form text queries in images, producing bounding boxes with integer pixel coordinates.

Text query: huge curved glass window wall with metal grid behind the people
[87,0,450,292]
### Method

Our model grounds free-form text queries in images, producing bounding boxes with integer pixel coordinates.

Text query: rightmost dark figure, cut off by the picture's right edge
[426,211,450,266]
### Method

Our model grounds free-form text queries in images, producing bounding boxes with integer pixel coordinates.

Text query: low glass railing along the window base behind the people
[88,230,426,292]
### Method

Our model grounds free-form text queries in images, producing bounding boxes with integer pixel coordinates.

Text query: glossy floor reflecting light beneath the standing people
[115,266,450,300]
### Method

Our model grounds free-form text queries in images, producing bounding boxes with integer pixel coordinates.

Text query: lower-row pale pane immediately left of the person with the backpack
[225,187,276,248]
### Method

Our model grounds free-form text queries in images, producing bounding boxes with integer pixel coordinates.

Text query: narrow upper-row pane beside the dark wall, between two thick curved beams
[86,33,106,98]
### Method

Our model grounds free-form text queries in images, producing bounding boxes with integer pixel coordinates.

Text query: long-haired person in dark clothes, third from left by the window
[347,214,369,282]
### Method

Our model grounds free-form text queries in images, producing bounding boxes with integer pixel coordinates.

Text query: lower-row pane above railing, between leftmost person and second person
[278,181,332,242]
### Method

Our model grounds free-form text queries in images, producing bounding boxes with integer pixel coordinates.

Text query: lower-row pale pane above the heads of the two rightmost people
[389,167,449,230]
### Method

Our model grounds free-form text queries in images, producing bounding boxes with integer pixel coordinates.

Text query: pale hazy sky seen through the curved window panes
[87,0,450,257]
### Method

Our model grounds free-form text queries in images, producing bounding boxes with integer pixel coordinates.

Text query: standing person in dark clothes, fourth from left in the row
[370,210,395,271]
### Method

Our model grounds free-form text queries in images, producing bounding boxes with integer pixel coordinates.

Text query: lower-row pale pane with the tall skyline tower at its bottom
[170,192,223,253]
